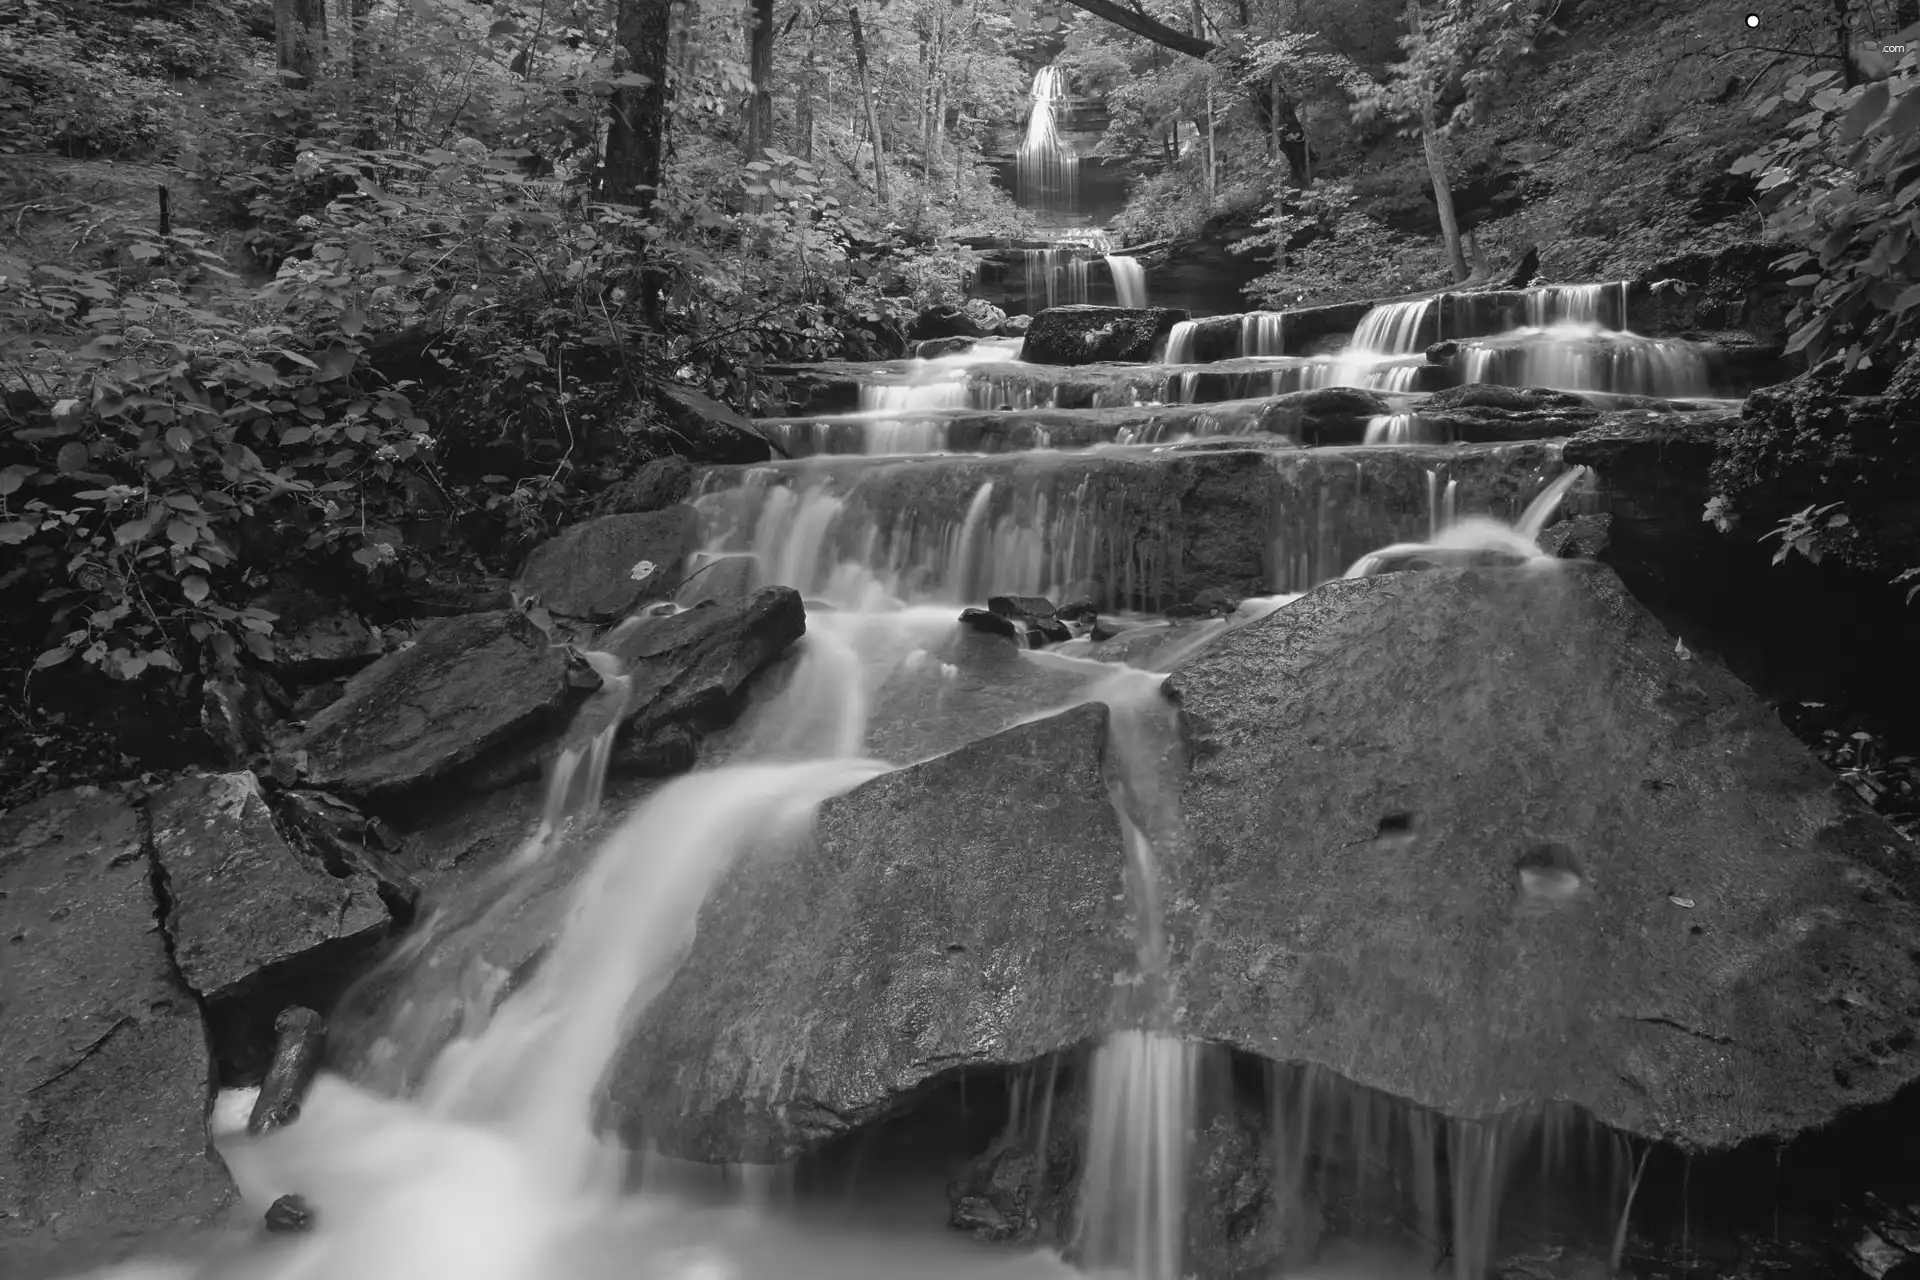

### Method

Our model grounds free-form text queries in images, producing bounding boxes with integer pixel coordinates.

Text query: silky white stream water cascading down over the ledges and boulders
[71,276,1728,1280]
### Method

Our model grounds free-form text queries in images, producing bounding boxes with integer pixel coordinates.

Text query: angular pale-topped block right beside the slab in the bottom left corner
[150,773,392,1034]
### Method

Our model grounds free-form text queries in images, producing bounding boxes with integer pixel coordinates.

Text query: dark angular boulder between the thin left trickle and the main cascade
[601,587,806,741]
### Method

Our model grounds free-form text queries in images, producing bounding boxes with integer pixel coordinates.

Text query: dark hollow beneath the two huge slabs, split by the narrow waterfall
[710,1046,1920,1280]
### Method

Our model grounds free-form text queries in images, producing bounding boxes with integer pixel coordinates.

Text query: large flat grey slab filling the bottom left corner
[0,787,232,1276]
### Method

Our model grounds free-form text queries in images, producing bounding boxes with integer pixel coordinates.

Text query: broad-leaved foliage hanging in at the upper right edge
[1734,45,1920,368]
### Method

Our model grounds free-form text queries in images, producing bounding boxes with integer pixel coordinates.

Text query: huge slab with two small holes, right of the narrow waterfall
[1169,562,1920,1148]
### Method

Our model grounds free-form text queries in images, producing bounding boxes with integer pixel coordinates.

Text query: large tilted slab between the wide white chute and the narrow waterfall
[611,706,1135,1161]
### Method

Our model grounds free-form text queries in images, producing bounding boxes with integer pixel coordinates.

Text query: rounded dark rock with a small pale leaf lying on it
[518,505,701,622]
